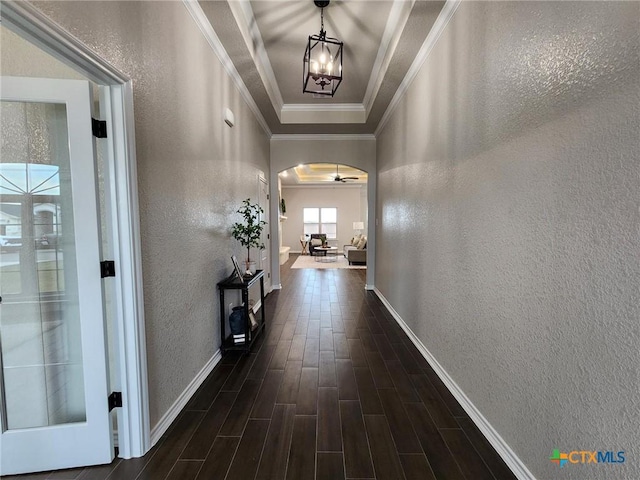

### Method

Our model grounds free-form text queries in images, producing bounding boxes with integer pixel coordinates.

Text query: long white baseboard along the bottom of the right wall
[374,287,536,480]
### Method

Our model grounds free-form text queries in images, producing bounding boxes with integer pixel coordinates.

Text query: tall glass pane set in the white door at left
[0,101,86,430]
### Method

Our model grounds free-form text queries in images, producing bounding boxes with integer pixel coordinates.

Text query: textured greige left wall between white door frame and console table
[35,1,269,426]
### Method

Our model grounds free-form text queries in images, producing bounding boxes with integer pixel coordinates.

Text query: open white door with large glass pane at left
[0,77,113,475]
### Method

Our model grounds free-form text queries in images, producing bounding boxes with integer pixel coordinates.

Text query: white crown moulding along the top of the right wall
[374,0,462,137]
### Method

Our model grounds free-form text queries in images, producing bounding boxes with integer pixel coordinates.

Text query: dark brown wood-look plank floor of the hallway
[7,255,515,480]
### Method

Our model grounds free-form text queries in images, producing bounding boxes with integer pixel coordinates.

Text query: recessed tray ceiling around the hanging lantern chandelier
[199,0,444,134]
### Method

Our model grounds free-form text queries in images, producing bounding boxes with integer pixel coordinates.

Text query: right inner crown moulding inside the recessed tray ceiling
[362,0,416,116]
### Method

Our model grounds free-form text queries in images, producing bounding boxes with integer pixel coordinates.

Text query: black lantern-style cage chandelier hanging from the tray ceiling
[302,0,343,97]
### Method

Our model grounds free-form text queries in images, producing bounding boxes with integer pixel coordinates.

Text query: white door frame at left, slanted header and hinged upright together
[0,1,151,458]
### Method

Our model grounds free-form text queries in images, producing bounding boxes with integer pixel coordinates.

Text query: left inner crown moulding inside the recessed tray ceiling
[228,0,284,117]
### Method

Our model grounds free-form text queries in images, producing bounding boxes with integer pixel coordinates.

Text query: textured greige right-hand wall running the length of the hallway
[376,2,640,480]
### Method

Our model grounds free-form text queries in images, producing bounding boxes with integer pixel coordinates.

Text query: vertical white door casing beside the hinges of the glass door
[107,82,151,458]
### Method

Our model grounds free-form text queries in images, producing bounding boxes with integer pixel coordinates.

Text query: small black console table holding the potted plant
[218,270,266,355]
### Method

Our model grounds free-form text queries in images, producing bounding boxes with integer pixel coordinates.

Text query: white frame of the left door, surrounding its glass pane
[0,76,114,475]
